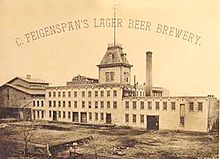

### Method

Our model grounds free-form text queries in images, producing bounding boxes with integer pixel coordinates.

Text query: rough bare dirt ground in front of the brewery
[0,122,219,159]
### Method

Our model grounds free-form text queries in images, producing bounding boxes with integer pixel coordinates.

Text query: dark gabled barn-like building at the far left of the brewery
[0,75,49,118]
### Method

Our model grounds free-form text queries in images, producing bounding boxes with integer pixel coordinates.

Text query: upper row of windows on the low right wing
[125,101,203,111]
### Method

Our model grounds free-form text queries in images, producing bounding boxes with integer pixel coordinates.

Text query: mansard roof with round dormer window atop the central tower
[97,44,132,68]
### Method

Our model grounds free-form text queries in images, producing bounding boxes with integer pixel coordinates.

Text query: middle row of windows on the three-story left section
[49,101,118,109]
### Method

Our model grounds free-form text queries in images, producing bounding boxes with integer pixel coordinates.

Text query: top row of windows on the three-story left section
[48,90,117,98]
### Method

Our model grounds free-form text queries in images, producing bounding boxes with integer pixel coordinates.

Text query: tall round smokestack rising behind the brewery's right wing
[145,51,152,96]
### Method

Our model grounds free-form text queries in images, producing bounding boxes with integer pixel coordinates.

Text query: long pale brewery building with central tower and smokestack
[32,44,218,132]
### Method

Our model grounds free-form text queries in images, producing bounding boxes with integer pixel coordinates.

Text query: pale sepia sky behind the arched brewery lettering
[0,0,220,98]
